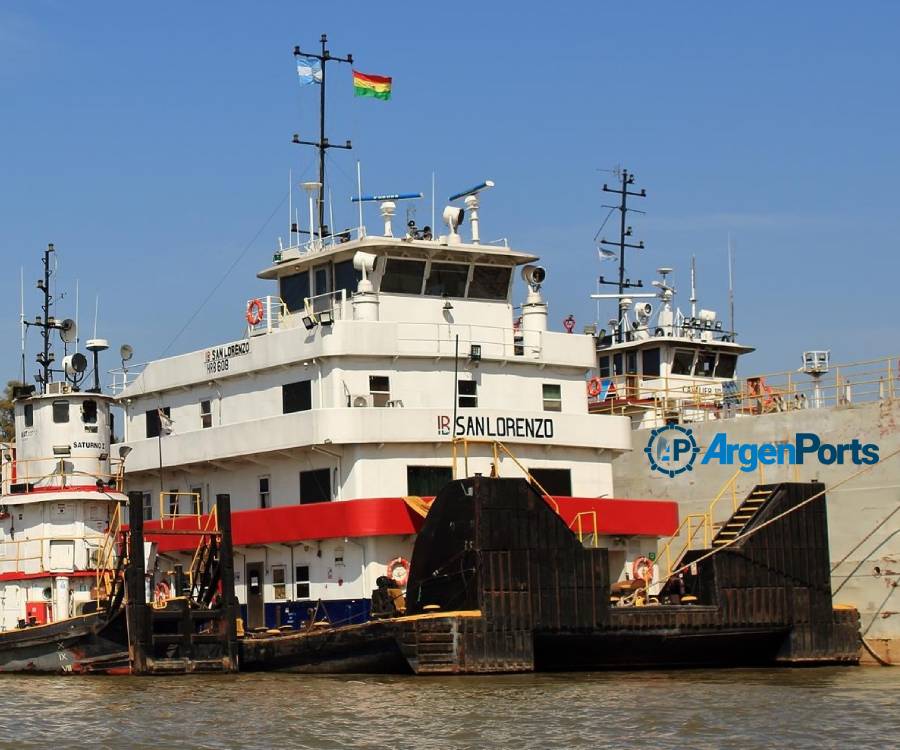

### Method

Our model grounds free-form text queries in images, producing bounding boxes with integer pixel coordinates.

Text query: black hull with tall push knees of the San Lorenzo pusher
[241,477,859,674]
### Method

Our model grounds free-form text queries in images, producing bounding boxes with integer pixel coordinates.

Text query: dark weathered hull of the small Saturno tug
[0,612,130,674]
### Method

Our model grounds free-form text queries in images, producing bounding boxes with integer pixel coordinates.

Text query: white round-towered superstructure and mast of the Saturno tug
[0,245,126,640]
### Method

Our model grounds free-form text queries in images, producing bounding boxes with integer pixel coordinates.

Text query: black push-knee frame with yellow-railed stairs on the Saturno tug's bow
[126,492,238,675]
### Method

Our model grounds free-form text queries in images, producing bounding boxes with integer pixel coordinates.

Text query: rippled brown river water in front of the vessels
[0,667,900,750]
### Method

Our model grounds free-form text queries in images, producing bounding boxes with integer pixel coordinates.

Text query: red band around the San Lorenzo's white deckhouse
[144,497,678,552]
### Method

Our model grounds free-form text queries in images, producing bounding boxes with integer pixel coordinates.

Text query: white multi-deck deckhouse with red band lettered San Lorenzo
[112,191,676,627]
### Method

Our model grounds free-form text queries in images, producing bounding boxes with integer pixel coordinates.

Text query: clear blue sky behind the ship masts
[0,0,900,379]
